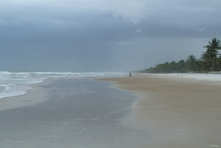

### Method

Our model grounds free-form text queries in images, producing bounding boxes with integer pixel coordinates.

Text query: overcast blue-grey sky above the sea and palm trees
[0,0,221,72]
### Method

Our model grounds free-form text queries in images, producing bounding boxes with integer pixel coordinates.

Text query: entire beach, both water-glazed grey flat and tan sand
[0,74,221,148]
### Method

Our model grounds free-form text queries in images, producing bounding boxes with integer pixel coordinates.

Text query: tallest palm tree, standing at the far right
[203,38,221,71]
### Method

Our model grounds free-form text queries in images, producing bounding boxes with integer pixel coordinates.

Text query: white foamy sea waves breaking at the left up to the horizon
[0,71,126,99]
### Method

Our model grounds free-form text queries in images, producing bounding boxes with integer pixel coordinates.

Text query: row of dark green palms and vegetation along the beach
[140,38,221,73]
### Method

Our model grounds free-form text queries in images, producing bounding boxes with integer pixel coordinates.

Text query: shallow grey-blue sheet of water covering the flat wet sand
[0,79,151,148]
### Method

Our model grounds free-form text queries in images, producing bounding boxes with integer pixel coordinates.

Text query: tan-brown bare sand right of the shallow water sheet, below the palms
[99,74,221,148]
